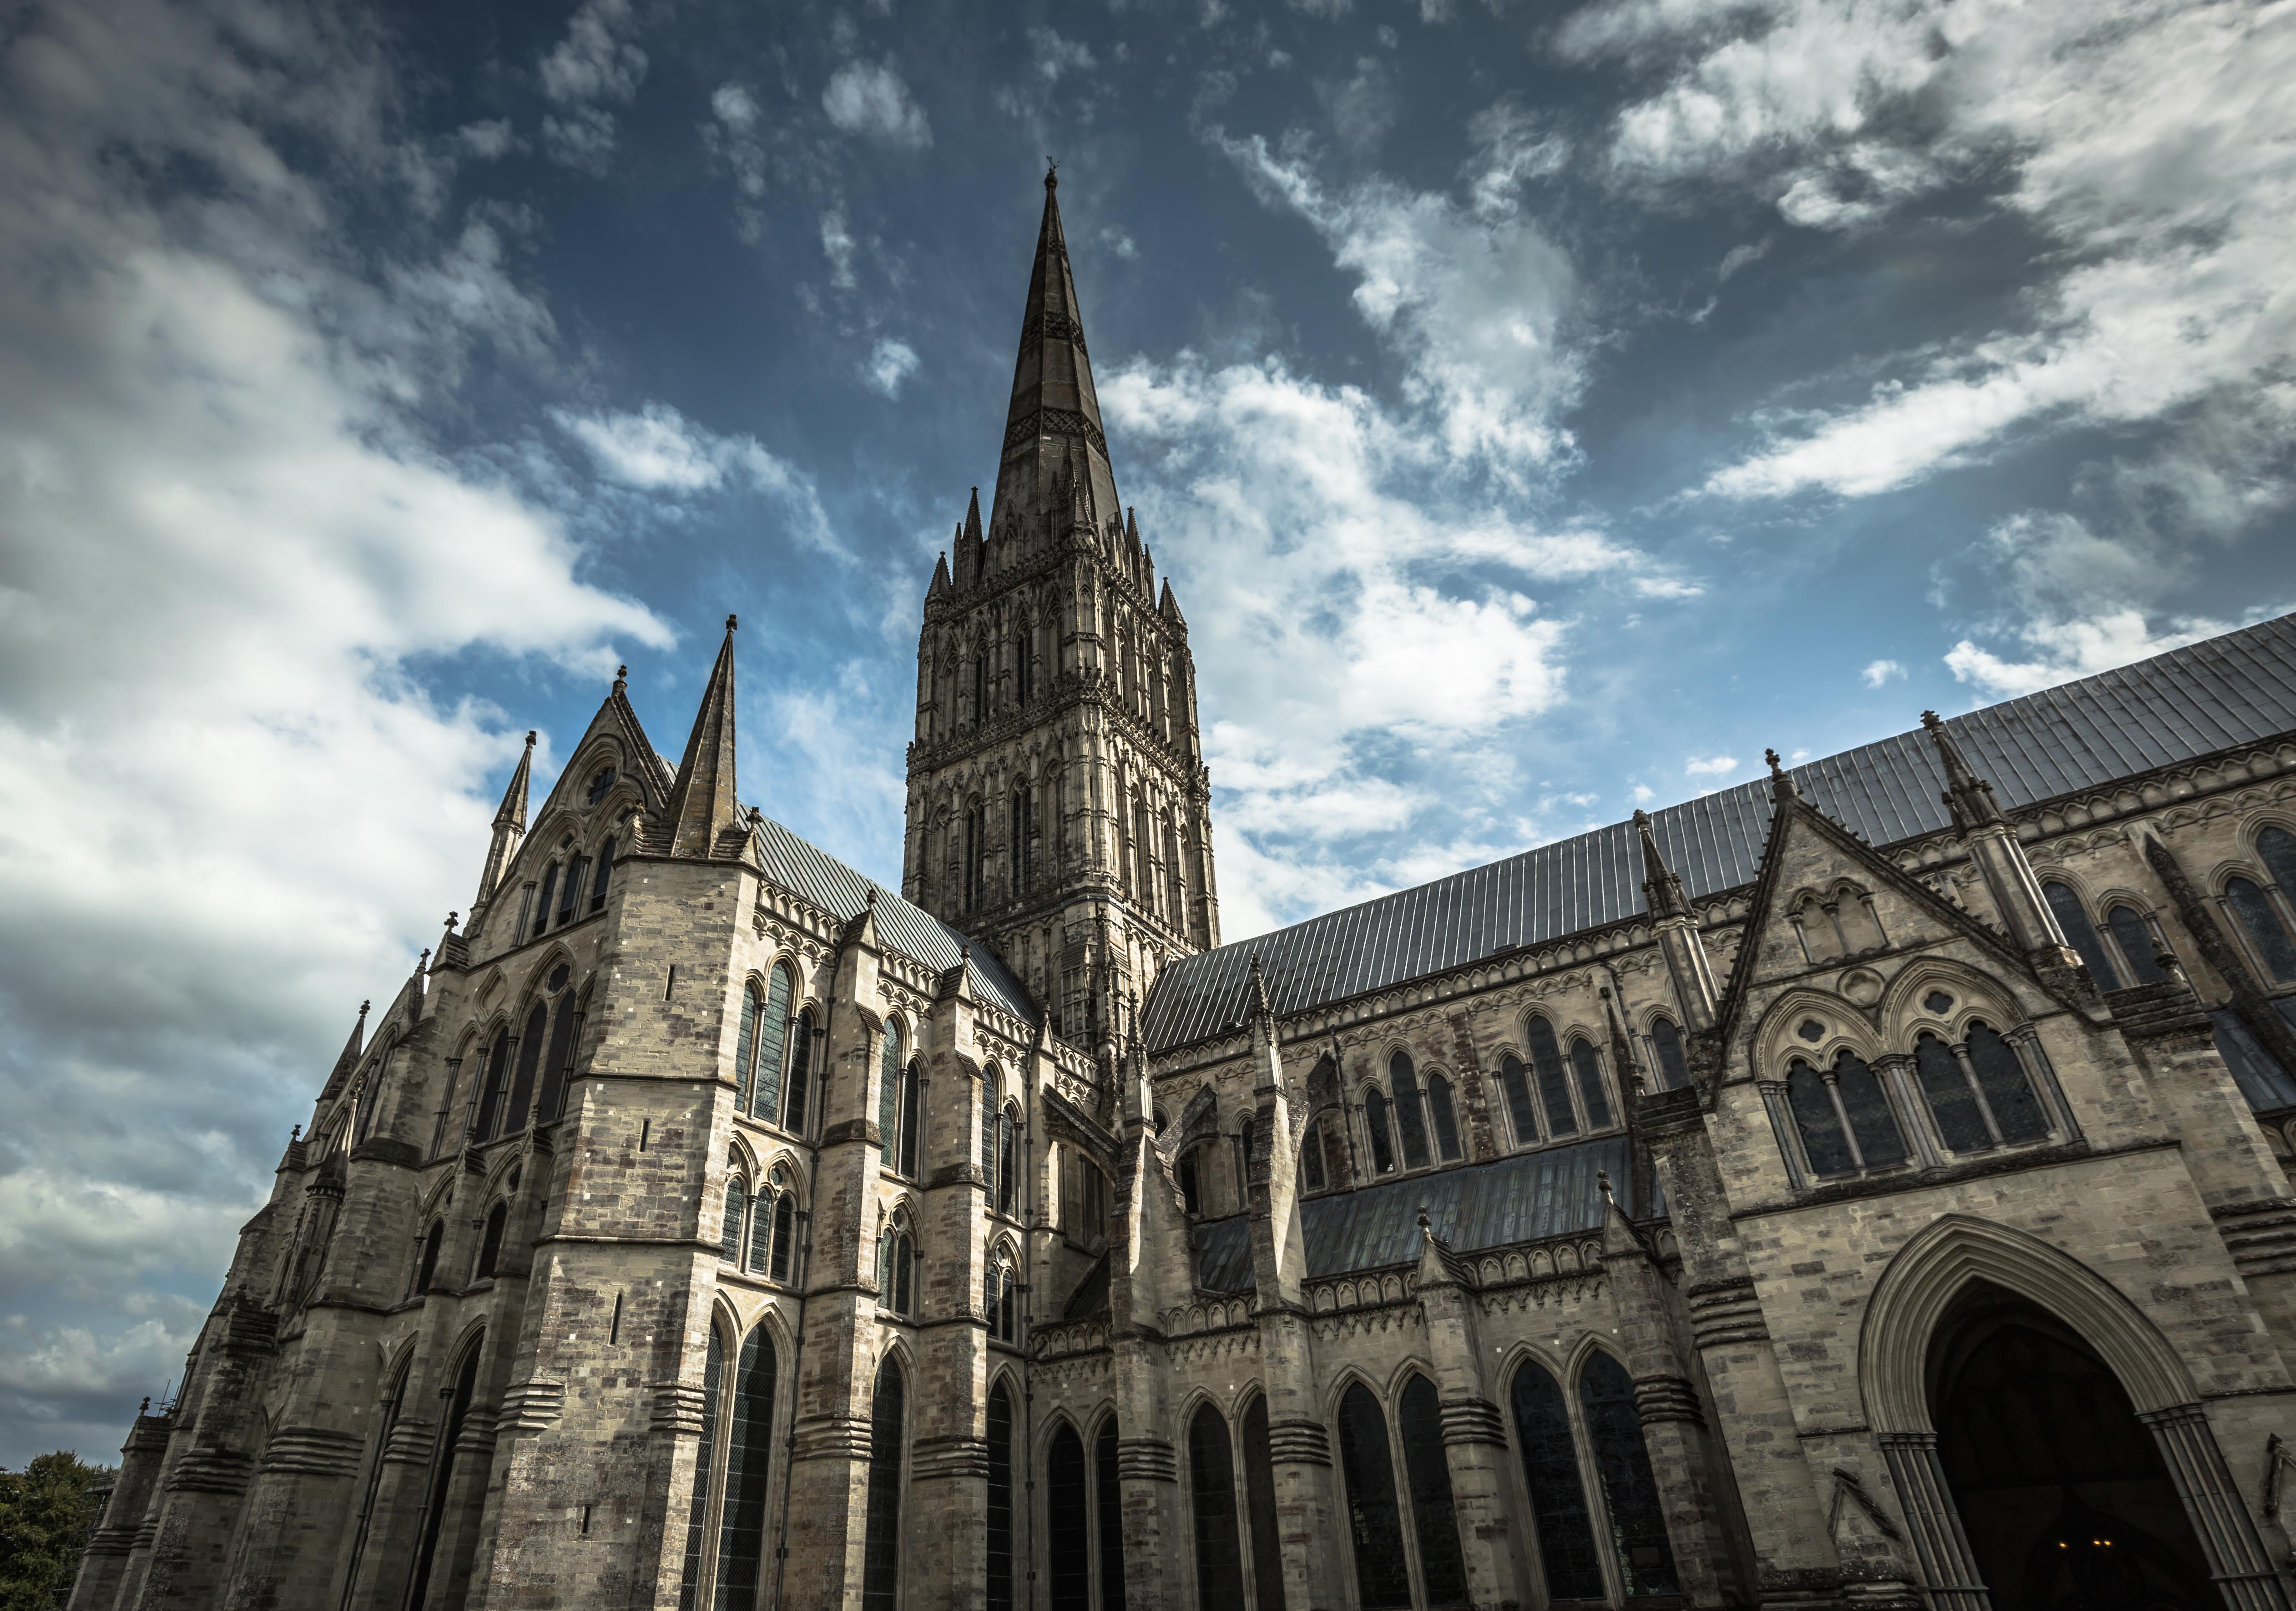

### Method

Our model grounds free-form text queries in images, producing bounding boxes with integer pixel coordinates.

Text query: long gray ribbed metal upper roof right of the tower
[1141,615,2296,1051]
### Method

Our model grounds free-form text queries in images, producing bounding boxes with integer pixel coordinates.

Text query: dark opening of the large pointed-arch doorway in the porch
[1928,1280,2220,1611]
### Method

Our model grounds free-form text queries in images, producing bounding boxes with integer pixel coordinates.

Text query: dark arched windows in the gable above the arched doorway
[1784,1023,2057,1179]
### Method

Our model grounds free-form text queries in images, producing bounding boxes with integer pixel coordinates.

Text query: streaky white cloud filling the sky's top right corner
[1559,0,2296,512]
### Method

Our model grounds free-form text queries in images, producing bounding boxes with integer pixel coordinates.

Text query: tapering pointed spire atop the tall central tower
[989,172,1118,537]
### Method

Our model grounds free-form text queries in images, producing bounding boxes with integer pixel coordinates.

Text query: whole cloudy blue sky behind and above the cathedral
[0,0,2296,1464]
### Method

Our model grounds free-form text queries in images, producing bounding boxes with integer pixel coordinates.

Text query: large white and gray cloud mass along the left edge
[0,0,668,1464]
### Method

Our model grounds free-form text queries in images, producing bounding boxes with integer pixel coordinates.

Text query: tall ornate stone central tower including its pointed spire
[902,172,1219,1051]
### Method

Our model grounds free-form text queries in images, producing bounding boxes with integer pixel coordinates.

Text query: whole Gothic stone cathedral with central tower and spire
[71,177,2296,1611]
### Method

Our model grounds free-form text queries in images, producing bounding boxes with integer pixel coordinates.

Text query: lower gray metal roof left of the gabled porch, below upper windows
[1196,1136,1662,1292]
